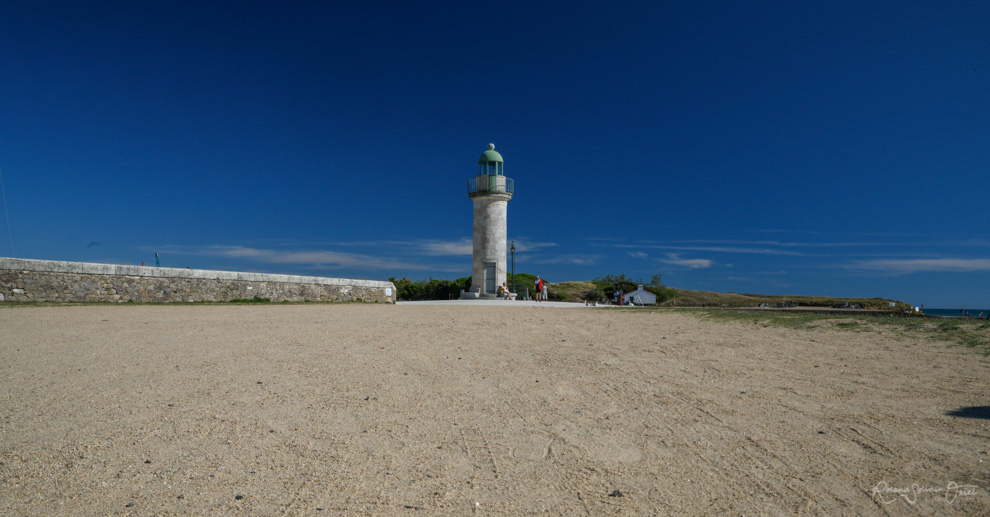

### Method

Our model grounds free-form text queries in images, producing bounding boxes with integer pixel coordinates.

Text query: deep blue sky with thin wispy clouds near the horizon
[0,1,990,307]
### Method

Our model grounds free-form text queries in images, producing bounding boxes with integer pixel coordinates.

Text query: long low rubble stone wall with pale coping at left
[0,257,396,303]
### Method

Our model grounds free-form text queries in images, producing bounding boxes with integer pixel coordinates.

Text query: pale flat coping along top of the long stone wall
[0,257,395,289]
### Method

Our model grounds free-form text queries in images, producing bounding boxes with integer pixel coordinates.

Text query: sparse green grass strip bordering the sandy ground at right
[684,310,990,355]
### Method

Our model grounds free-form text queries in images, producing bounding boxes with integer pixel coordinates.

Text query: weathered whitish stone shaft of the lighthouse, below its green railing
[461,192,512,299]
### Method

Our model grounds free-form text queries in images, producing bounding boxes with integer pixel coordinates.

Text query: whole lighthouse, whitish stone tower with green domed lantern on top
[463,144,514,298]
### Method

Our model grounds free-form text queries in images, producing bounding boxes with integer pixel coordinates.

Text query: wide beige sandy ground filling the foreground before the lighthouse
[0,305,990,515]
